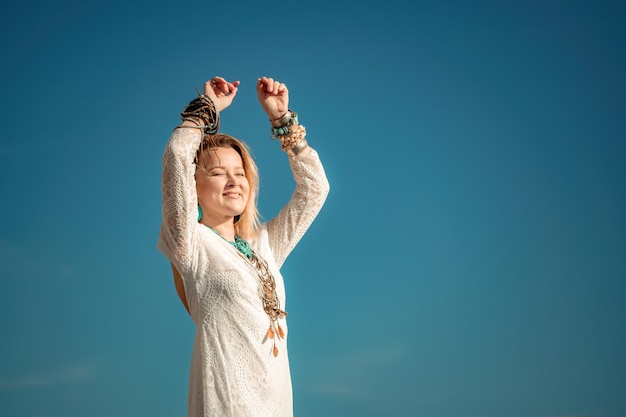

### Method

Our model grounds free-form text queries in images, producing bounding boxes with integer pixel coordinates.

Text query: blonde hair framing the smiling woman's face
[195,133,261,240]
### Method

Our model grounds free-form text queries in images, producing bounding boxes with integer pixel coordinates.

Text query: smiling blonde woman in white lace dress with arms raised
[158,77,329,417]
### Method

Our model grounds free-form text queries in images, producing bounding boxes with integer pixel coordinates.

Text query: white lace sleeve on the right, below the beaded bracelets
[267,149,330,268]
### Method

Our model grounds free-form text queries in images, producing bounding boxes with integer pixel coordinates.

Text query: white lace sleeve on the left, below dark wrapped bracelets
[157,128,201,273]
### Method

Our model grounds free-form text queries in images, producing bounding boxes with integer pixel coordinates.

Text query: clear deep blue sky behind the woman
[0,0,626,417]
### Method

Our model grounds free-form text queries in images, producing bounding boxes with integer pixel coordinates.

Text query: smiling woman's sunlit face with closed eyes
[196,147,250,226]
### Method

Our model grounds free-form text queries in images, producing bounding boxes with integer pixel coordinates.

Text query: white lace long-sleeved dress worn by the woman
[157,128,329,417]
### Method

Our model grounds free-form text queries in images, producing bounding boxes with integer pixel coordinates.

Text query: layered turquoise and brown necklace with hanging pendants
[210,227,287,357]
